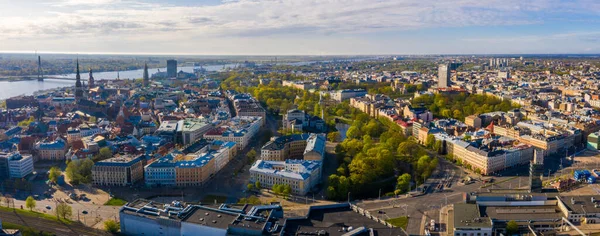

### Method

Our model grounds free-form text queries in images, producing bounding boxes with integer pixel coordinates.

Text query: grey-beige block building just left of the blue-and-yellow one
[92,155,146,186]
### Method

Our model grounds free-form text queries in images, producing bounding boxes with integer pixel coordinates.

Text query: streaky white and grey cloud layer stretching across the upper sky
[0,0,600,53]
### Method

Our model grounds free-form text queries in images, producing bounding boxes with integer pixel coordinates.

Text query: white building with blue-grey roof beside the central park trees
[250,160,321,195]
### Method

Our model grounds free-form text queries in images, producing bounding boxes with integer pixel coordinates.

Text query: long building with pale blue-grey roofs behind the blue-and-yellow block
[204,116,263,150]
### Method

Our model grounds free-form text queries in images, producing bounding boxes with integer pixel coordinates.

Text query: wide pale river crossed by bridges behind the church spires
[0,64,236,100]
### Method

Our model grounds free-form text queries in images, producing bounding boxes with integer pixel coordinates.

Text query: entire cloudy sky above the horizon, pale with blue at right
[0,0,600,55]
